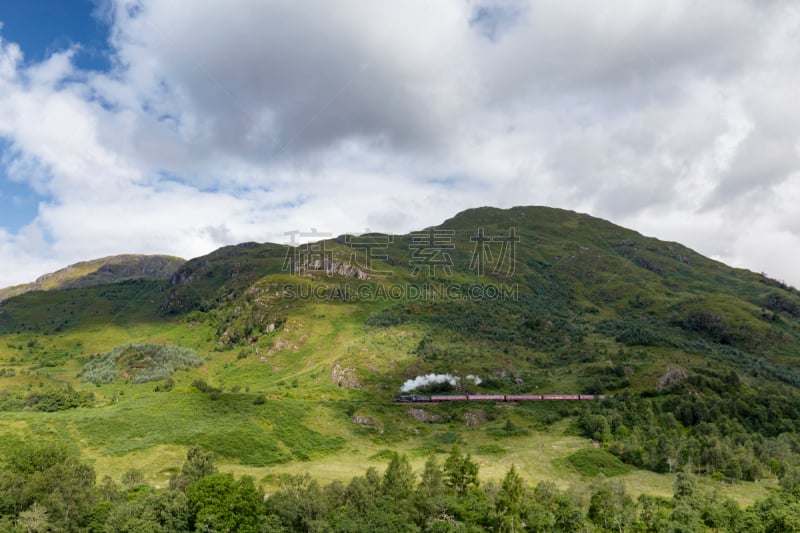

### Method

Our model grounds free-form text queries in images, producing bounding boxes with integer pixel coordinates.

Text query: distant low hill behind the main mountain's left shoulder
[0,254,185,302]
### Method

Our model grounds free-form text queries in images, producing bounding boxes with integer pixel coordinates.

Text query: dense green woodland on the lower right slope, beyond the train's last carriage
[578,370,800,482]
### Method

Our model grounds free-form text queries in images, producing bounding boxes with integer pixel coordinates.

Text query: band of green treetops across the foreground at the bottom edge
[0,442,800,533]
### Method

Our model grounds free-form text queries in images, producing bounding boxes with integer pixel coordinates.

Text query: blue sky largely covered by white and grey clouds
[0,0,800,286]
